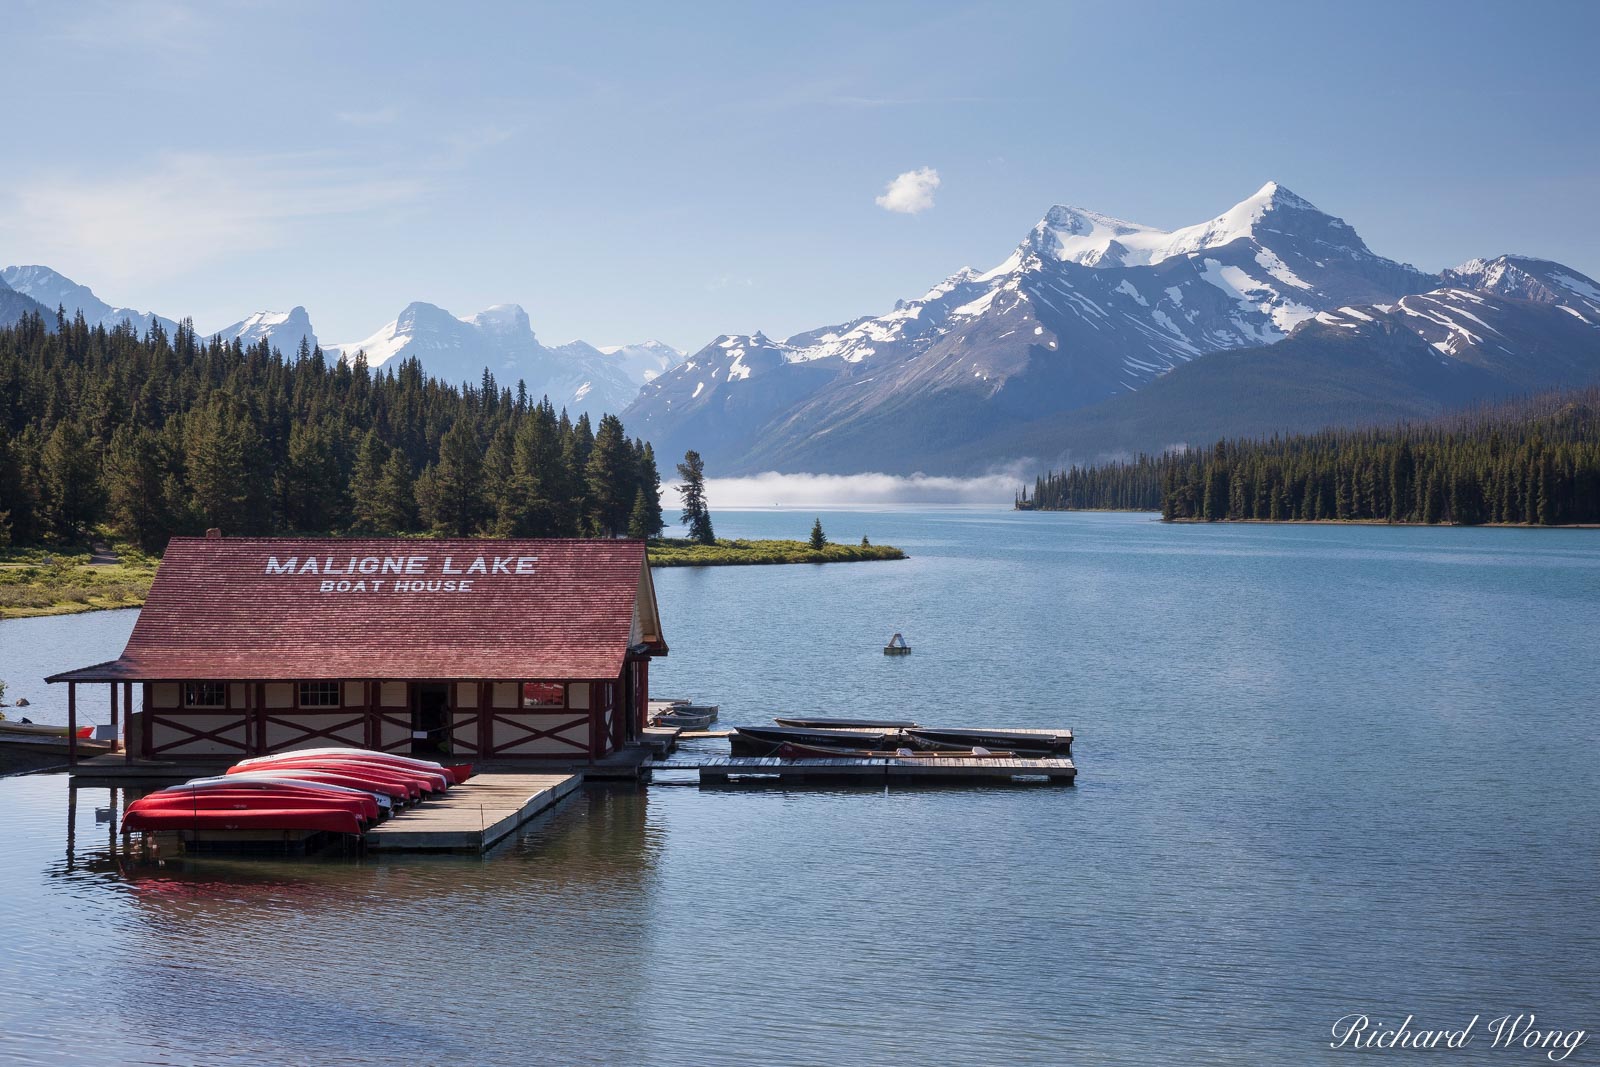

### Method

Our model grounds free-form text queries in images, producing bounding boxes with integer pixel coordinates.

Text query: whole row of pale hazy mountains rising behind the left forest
[0,266,683,418]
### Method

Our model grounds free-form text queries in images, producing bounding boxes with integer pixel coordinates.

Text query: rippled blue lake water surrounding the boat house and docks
[0,512,1600,1065]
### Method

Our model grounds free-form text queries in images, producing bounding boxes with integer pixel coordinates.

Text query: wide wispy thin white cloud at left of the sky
[0,152,422,283]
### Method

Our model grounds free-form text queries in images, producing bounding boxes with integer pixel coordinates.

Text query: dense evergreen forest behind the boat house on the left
[0,303,662,552]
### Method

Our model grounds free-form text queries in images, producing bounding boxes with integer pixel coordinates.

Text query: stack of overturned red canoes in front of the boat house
[122,749,472,835]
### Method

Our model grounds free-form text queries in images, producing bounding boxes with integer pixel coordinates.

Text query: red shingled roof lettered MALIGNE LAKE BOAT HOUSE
[54,537,666,681]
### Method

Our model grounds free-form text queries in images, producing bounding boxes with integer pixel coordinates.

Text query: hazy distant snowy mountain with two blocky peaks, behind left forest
[323,302,643,418]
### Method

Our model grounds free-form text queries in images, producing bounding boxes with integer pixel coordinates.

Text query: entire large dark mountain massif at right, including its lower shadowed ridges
[624,182,1600,474]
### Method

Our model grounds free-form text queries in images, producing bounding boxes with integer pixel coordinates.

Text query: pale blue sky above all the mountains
[0,0,1600,349]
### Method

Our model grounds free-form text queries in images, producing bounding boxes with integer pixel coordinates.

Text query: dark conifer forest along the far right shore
[1016,387,1600,526]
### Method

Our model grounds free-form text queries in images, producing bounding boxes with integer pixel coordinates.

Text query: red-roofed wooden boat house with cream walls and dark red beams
[48,531,667,763]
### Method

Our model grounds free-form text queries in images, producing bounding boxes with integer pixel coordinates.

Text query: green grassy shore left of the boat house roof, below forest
[0,545,157,619]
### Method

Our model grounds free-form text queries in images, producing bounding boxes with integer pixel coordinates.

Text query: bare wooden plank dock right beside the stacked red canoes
[365,774,584,853]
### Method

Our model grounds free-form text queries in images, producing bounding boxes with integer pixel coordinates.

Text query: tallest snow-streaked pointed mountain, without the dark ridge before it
[626,182,1438,474]
